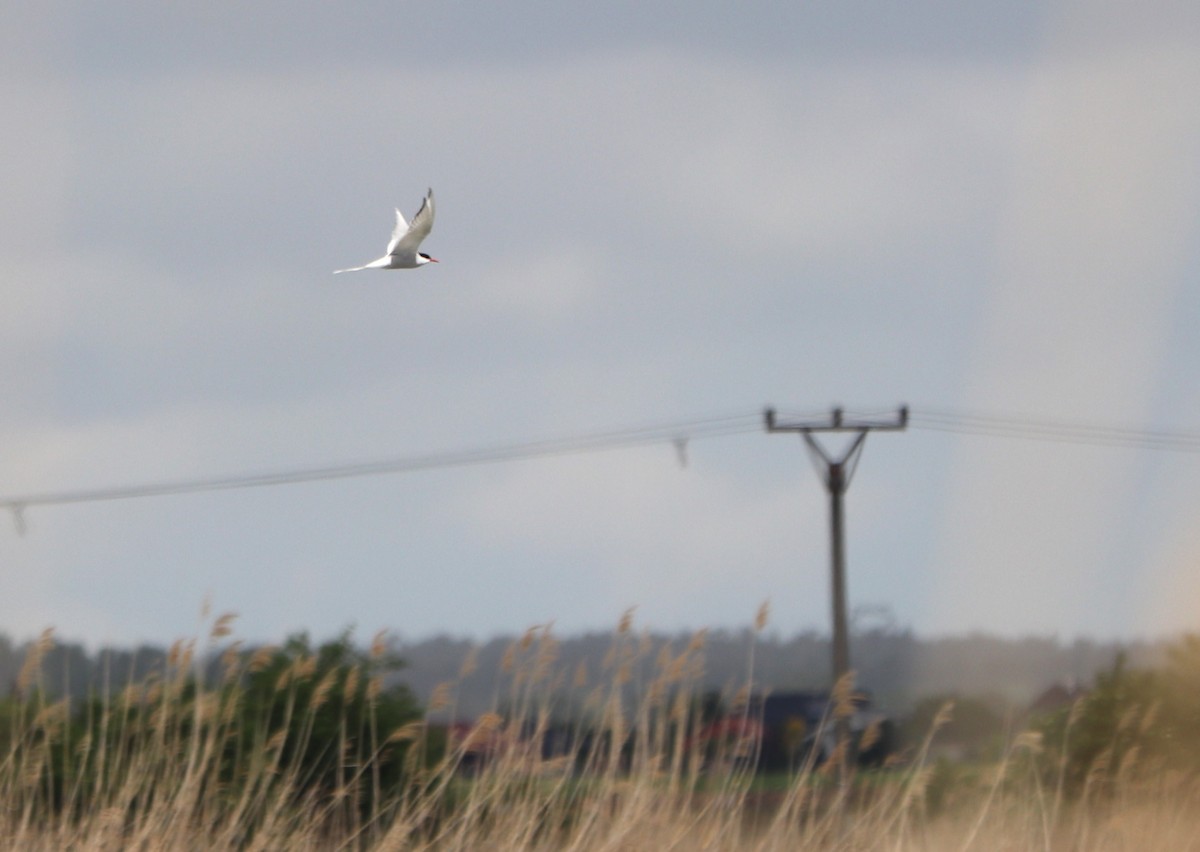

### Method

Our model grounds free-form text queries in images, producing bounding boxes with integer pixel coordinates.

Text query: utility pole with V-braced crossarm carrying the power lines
[764,406,908,781]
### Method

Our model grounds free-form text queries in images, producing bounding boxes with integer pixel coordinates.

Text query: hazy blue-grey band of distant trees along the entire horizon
[0,629,1169,719]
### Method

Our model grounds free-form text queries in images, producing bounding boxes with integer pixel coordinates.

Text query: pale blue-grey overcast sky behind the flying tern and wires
[0,0,1200,643]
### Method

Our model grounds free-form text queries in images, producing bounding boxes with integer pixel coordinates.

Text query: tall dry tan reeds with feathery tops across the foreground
[0,610,1200,852]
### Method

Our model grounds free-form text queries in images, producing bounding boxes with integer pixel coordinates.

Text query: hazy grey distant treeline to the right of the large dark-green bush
[394,629,1169,718]
